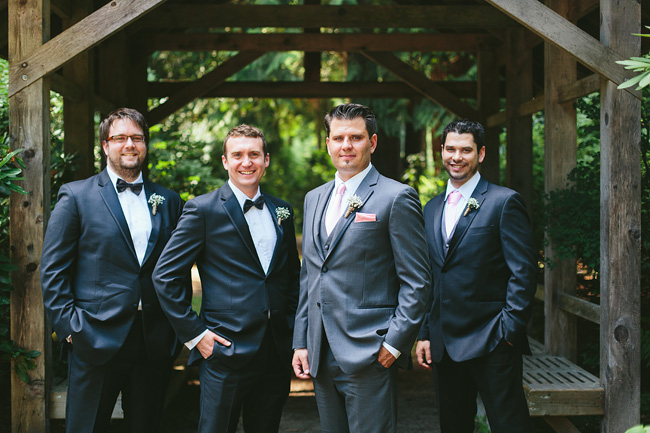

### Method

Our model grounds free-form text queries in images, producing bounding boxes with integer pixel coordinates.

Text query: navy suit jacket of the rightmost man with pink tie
[418,178,537,362]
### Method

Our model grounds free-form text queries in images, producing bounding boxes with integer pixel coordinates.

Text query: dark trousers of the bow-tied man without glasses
[199,323,291,433]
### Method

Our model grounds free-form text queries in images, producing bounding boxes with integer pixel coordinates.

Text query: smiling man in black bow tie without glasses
[154,125,300,433]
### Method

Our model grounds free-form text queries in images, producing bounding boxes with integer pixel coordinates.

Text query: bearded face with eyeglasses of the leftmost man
[102,119,147,182]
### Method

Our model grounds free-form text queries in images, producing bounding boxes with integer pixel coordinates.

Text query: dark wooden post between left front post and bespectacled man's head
[63,0,95,179]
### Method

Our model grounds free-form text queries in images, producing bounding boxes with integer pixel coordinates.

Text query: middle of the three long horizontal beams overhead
[143,33,500,52]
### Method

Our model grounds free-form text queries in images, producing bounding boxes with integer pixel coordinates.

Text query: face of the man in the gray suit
[327,117,377,182]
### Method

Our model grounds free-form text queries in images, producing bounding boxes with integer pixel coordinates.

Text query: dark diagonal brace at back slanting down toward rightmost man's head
[362,51,478,119]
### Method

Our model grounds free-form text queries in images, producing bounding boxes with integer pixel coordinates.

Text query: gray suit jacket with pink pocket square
[293,168,430,377]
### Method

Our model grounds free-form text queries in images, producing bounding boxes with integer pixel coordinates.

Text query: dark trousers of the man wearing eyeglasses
[66,311,173,433]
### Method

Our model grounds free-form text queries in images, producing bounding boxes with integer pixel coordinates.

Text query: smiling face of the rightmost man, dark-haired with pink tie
[442,132,485,188]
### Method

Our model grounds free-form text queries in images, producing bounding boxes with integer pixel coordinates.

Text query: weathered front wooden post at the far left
[8,0,51,433]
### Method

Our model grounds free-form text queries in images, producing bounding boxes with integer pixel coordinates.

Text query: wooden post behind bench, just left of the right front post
[544,0,578,361]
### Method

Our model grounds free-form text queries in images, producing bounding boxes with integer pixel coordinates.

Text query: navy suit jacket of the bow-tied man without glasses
[154,184,300,368]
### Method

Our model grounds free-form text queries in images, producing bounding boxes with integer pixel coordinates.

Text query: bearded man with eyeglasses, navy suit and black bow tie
[41,108,186,433]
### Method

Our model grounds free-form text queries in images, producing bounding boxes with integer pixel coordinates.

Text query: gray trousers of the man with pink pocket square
[314,338,397,433]
